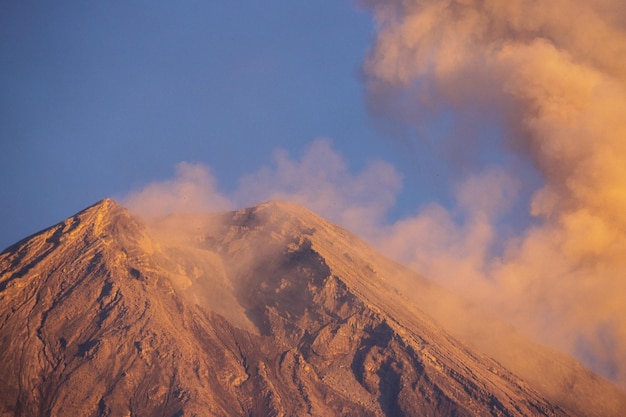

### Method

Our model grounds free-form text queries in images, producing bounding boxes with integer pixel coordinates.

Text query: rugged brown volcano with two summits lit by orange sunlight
[0,199,626,416]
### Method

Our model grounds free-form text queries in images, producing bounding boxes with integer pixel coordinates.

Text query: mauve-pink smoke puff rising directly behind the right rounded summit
[235,139,402,236]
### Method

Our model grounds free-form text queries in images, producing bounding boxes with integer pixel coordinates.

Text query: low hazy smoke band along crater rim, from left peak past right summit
[122,139,402,236]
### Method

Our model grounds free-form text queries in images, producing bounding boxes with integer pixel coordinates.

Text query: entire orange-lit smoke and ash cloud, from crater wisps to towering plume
[119,0,626,387]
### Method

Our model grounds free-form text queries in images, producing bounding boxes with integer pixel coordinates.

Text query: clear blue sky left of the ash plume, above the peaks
[0,0,444,248]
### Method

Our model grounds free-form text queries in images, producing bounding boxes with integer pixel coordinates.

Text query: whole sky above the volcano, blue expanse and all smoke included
[0,0,626,388]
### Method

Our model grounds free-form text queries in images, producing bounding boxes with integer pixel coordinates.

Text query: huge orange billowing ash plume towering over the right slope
[358,0,626,386]
